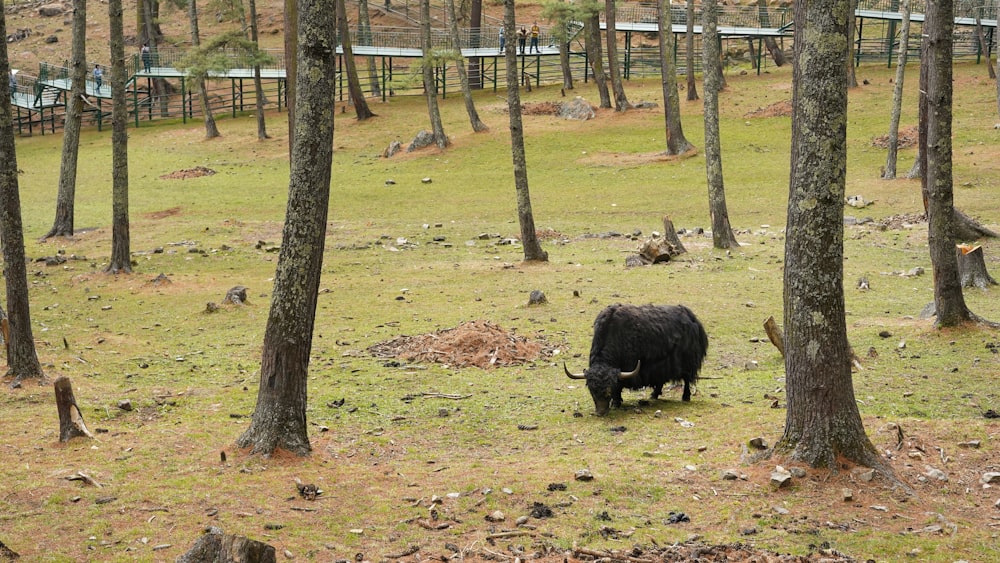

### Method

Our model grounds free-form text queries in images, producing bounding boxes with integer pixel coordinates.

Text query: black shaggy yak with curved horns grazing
[563,304,708,416]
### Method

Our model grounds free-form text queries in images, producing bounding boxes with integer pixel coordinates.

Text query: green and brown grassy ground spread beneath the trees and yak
[0,59,1000,561]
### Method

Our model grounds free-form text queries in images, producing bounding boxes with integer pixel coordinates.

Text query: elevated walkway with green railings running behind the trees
[10,0,1000,134]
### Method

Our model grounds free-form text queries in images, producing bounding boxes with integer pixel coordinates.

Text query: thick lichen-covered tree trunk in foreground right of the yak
[775,0,884,470]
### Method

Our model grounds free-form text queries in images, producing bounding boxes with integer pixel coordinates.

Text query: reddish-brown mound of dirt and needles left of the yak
[368,320,551,369]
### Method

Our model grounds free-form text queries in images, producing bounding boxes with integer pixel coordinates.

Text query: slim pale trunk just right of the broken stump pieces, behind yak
[700,0,740,249]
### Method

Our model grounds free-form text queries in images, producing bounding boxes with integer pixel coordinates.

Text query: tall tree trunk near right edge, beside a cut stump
[922,0,972,327]
